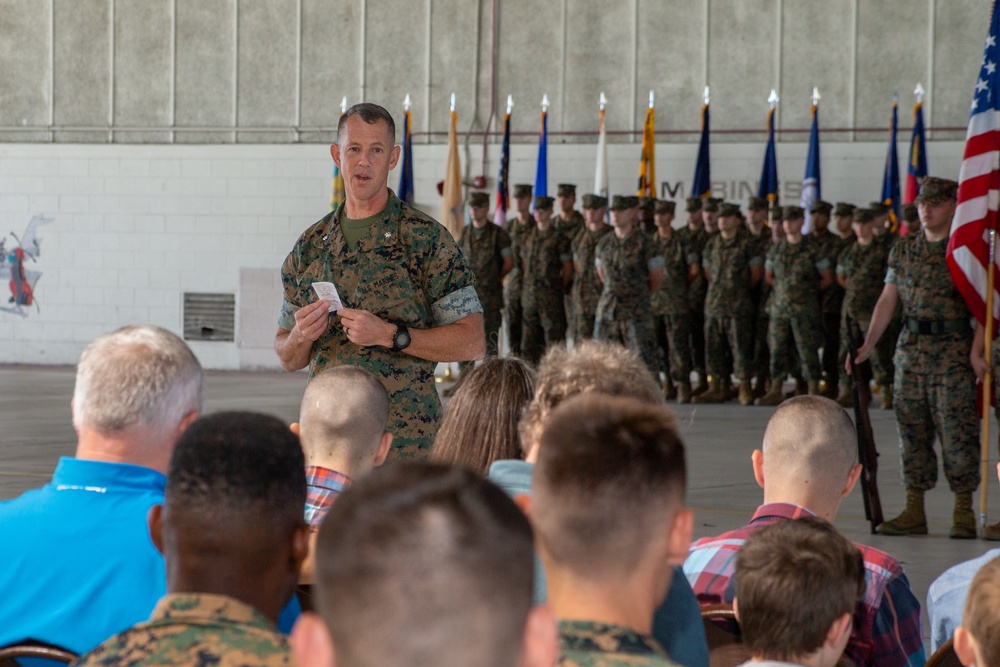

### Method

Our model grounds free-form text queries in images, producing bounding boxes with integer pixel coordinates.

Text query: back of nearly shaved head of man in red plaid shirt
[763,396,858,493]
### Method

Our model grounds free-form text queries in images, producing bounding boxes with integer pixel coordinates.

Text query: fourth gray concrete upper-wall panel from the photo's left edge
[174,0,235,143]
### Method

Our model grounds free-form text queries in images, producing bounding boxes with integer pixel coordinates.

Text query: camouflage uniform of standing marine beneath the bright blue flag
[515,224,572,364]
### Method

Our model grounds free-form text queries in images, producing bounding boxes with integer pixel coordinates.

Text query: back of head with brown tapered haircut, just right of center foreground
[531,393,686,580]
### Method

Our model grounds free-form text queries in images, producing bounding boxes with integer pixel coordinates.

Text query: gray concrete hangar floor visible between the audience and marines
[0,366,1000,648]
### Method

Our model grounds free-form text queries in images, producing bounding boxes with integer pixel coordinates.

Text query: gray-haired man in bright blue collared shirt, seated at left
[0,326,202,653]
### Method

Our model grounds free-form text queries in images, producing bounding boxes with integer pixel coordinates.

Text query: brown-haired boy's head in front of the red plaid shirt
[733,517,865,667]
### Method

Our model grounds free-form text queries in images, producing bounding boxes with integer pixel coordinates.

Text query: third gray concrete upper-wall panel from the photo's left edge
[114,0,174,143]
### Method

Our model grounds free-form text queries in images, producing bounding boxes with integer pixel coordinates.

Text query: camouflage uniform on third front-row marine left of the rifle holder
[702,230,762,381]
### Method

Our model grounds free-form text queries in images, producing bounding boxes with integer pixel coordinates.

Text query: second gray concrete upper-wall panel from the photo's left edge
[53,0,111,141]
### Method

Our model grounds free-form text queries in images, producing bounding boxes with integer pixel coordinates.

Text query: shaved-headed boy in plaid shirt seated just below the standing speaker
[291,366,392,568]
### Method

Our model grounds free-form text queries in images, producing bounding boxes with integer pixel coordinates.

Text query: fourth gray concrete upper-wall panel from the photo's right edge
[708,0,781,141]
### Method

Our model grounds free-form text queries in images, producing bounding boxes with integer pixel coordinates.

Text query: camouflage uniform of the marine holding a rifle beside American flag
[885,234,979,490]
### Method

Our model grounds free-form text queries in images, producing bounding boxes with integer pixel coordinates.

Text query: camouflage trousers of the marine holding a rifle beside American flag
[893,370,979,493]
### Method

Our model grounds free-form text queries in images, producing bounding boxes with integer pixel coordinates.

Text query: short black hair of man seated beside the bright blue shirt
[164,412,306,524]
